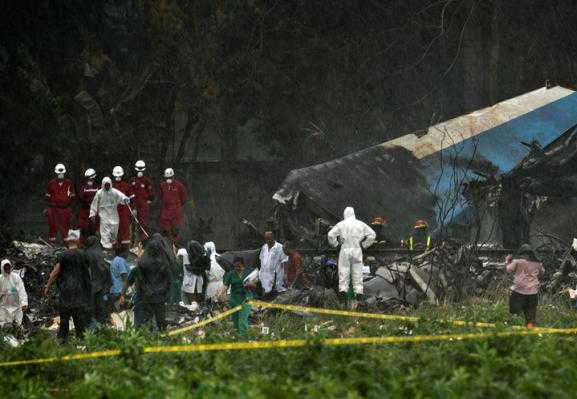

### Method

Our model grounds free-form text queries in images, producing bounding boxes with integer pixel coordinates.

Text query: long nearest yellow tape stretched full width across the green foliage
[0,328,577,367]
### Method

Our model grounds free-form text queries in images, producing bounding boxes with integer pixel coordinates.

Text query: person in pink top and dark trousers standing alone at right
[505,244,545,328]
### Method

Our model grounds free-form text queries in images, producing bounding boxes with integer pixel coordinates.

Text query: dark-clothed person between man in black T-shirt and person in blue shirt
[84,236,112,324]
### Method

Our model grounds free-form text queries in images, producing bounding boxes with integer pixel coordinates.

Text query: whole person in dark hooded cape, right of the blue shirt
[120,233,174,331]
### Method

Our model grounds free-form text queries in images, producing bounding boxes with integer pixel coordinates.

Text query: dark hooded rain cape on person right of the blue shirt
[136,233,174,303]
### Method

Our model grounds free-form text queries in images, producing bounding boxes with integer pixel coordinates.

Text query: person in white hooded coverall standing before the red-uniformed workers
[90,176,130,250]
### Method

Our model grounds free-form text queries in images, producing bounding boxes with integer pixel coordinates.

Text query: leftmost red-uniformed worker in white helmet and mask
[46,163,75,244]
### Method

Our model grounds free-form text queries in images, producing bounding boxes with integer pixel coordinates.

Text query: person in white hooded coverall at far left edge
[0,259,28,327]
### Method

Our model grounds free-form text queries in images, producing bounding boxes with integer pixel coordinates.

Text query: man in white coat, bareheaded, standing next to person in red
[258,231,288,295]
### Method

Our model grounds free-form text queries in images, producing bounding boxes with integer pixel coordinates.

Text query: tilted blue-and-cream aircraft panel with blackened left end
[273,87,577,245]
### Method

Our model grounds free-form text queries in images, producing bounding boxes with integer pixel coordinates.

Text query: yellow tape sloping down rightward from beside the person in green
[247,301,500,328]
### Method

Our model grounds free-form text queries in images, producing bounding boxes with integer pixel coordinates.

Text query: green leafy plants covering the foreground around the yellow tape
[0,300,577,398]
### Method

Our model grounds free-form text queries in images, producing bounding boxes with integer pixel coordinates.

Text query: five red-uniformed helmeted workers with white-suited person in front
[46,160,187,250]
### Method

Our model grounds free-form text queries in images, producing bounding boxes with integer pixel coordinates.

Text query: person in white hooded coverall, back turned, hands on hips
[327,207,377,298]
